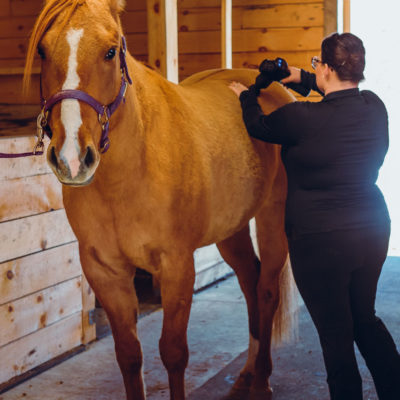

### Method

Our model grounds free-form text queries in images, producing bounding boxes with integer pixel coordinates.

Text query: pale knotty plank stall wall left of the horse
[0,135,95,389]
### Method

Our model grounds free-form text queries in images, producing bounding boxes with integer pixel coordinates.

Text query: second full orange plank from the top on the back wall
[179,27,323,54]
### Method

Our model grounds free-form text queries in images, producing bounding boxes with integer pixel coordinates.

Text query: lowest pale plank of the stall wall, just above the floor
[0,312,82,383]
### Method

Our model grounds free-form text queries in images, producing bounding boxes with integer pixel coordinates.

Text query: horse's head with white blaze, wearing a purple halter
[24,0,129,185]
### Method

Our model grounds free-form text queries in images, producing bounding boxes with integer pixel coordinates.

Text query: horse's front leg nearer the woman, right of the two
[160,254,195,400]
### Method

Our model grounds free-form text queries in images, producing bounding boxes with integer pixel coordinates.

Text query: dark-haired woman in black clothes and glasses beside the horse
[230,33,400,400]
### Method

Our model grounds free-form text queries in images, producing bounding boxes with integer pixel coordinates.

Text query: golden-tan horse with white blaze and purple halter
[25,0,293,400]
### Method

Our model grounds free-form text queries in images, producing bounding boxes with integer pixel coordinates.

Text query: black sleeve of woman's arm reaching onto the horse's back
[240,85,298,145]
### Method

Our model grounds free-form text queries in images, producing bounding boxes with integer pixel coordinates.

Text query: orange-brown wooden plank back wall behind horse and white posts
[0,0,336,104]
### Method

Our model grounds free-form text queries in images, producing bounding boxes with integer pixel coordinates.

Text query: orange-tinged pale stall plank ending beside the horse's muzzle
[0,173,63,222]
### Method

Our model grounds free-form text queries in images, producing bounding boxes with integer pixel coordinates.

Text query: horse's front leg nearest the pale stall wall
[80,246,146,400]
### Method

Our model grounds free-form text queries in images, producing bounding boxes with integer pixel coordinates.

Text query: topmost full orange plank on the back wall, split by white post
[178,3,324,32]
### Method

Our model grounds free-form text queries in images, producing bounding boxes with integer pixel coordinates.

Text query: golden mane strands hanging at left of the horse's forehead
[22,0,85,95]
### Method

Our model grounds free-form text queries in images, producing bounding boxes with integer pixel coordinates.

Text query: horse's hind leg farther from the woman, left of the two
[217,226,260,399]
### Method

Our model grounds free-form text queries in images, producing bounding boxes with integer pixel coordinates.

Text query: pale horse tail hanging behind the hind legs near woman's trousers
[272,257,299,346]
